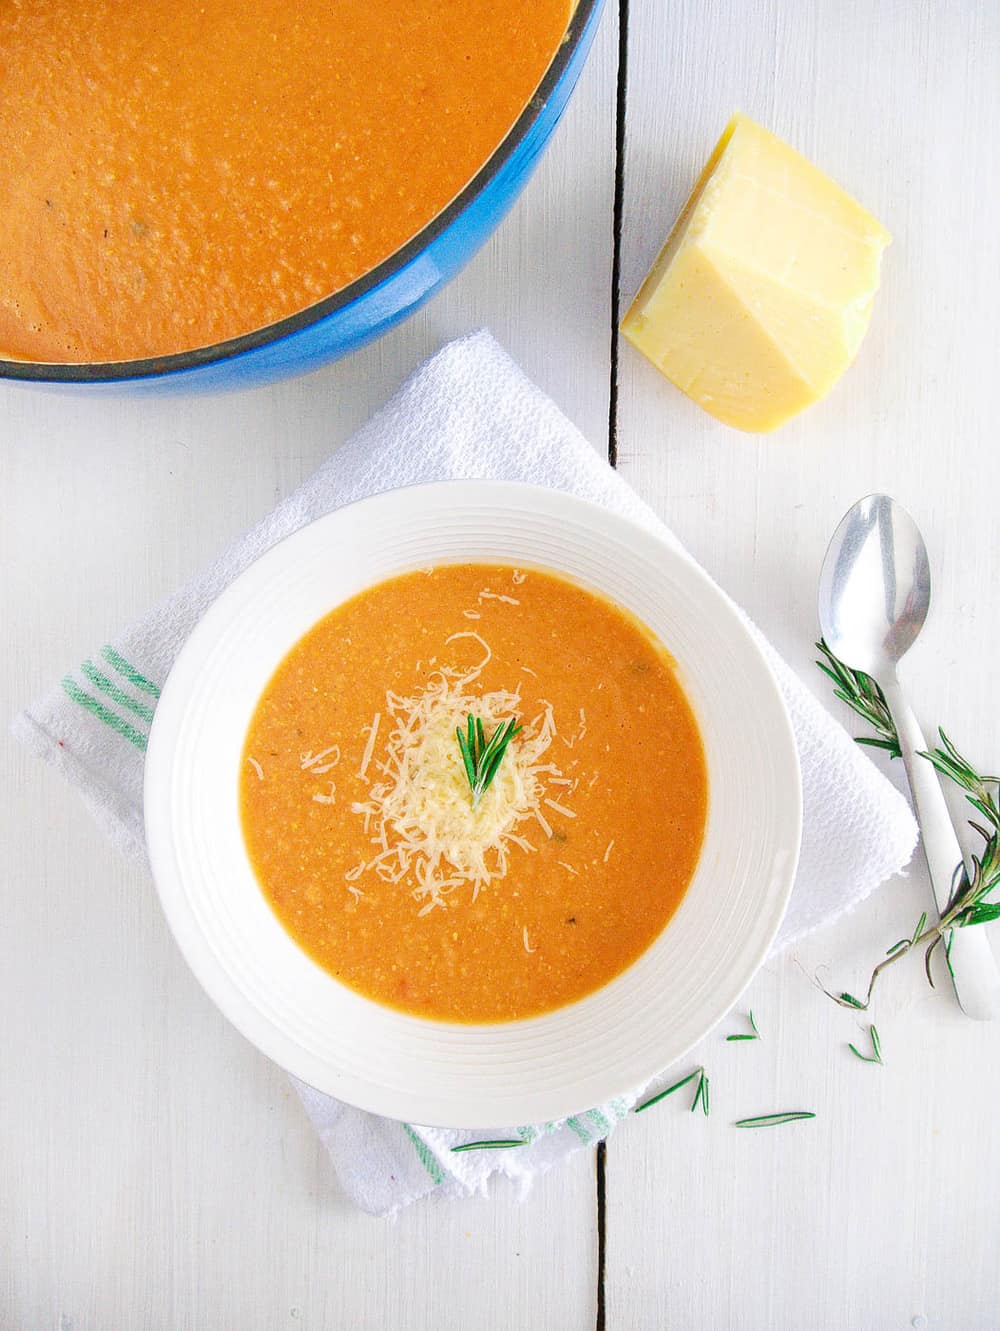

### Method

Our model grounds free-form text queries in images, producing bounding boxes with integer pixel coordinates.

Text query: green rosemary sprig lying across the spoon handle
[816,640,1000,1012]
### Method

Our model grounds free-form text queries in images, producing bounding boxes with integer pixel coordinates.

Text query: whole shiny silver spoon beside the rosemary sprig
[819,495,1000,1021]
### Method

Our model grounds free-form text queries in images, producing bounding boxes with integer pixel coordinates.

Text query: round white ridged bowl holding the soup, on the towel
[145,480,802,1127]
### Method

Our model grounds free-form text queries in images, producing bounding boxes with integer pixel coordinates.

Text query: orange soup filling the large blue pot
[0,0,571,362]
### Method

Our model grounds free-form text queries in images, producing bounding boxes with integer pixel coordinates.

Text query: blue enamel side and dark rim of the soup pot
[0,0,603,393]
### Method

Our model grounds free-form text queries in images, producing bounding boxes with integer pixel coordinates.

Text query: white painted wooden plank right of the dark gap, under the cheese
[607,0,1000,1331]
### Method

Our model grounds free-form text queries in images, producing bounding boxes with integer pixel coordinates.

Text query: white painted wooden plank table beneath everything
[0,0,1000,1331]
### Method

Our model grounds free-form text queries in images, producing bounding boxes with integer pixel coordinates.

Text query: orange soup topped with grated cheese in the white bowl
[240,564,707,1022]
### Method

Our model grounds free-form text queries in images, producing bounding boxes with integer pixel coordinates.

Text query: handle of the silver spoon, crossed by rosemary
[881,679,1000,1021]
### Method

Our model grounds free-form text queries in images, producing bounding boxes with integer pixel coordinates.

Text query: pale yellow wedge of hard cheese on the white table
[622,116,891,431]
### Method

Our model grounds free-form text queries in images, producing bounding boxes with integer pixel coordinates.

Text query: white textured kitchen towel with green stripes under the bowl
[15,331,916,1215]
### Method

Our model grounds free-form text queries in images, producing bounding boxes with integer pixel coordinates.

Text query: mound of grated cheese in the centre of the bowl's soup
[350,631,575,916]
